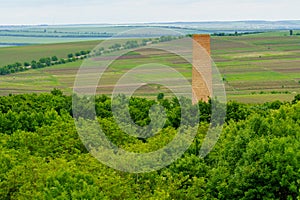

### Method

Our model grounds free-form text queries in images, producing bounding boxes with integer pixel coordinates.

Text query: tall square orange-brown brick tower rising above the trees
[192,34,212,104]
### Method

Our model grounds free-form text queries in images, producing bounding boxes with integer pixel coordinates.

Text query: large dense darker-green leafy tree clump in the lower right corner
[208,104,300,199]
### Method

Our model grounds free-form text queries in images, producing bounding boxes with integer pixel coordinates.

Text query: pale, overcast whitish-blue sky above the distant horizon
[0,0,300,25]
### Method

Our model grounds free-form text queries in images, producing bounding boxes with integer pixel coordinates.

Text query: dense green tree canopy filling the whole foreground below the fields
[0,90,300,199]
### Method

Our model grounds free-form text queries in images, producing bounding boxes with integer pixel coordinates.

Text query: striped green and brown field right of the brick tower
[212,33,300,102]
